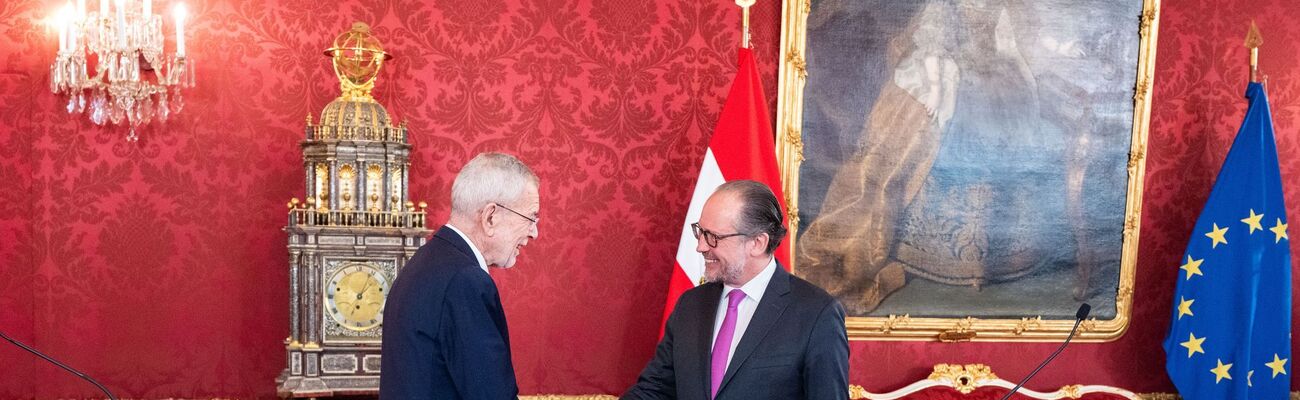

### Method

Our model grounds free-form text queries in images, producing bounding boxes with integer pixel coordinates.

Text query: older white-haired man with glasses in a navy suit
[380,153,540,400]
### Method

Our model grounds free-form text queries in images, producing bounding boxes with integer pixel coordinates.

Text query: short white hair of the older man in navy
[451,152,538,217]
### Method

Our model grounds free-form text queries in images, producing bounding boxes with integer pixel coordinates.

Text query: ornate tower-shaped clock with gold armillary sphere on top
[276,23,429,397]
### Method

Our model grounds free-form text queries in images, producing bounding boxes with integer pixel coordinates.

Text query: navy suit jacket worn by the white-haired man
[380,227,519,400]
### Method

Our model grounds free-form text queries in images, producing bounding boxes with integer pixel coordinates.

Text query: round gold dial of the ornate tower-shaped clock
[325,262,389,331]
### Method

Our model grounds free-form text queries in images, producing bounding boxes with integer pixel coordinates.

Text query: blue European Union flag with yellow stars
[1165,83,1291,400]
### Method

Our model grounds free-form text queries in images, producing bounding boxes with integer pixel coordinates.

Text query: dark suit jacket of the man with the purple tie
[623,265,849,400]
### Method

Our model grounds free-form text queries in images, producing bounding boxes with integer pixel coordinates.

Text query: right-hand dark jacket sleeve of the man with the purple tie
[803,300,849,400]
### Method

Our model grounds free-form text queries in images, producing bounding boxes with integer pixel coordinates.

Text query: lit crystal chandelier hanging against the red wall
[49,0,194,142]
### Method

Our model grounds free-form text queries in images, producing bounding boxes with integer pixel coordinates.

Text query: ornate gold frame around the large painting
[776,0,1167,342]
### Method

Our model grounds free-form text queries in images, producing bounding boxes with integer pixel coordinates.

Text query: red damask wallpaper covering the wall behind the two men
[0,0,1300,399]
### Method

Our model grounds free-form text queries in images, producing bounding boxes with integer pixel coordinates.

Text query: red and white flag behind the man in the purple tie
[660,48,789,335]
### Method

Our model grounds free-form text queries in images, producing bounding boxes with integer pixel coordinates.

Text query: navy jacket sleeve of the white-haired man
[442,268,519,400]
